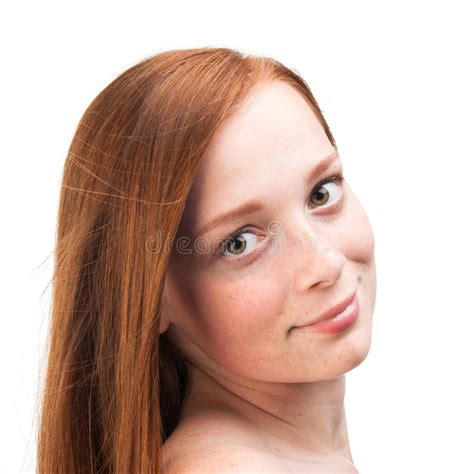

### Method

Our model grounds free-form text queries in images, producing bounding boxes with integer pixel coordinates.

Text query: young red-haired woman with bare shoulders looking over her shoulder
[38,48,376,474]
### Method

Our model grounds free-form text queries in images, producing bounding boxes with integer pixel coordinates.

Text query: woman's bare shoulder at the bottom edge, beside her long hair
[164,436,288,474]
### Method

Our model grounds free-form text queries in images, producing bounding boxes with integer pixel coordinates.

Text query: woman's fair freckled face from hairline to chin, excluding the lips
[161,82,376,382]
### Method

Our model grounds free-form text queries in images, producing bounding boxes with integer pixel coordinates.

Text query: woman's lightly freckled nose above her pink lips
[290,225,347,292]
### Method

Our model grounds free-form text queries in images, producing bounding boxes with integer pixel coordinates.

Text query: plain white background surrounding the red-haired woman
[0,0,474,474]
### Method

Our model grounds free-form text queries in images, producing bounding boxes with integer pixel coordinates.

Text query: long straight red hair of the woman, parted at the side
[37,48,337,474]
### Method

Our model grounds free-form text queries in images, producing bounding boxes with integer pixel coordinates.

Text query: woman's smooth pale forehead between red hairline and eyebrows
[183,81,334,233]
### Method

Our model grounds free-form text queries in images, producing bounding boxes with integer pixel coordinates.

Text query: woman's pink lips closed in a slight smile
[296,292,359,333]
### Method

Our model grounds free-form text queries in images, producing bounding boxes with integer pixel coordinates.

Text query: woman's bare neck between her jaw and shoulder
[183,365,353,463]
